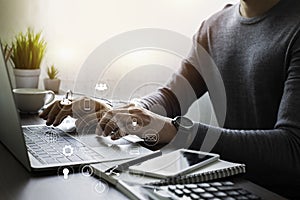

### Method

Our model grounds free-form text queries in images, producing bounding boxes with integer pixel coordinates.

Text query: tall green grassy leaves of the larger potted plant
[10,28,47,69]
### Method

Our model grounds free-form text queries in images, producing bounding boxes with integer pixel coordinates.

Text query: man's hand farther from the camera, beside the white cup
[39,97,111,126]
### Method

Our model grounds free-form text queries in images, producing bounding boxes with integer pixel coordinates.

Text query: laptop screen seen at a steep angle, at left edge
[0,46,31,170]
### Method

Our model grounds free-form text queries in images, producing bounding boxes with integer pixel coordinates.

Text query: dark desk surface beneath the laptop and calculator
[0,113,288,200]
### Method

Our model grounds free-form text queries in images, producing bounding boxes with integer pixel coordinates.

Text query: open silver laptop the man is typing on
[0,47,151,171]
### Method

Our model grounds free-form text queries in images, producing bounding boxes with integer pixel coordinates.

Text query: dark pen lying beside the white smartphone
[105,150,162,175]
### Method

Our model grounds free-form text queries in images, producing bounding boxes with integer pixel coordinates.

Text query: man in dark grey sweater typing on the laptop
[41,0,300,198]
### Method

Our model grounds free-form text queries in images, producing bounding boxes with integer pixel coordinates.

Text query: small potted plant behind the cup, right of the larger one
[44,65,60,93]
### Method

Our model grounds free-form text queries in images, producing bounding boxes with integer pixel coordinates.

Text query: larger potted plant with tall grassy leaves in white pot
[10,28,46,88]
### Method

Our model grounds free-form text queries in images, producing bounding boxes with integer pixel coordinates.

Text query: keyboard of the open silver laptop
[23,126,103,164]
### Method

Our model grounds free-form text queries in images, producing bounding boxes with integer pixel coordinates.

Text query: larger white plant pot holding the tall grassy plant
[14,69,41,88]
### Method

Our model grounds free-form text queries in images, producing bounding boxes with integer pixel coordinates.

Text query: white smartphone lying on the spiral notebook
[129,149,219,178]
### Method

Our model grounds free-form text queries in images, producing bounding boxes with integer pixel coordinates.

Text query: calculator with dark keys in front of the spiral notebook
[156,181,261,200]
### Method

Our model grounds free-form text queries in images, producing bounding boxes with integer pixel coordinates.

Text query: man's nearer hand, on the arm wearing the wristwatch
[96,104,177,143]
